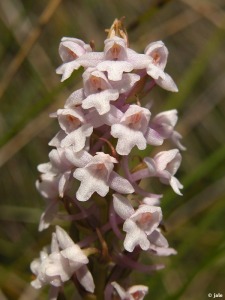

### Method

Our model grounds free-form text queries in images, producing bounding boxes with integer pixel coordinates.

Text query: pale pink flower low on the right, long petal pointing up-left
[113,194,162,252]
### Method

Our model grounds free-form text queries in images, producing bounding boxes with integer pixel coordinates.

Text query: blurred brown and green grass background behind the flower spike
[0,0,225,300]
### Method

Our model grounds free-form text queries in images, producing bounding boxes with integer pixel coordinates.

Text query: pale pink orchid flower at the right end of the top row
[145,41,178,92]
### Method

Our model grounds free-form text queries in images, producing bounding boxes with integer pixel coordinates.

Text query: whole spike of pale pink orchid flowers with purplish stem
[31,20,184,300]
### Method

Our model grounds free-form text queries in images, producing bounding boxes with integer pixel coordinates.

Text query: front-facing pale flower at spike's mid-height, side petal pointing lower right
[74,152,134,201]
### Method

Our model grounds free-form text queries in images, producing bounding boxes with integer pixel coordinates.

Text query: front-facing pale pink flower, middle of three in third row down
[111,105,151,155]
